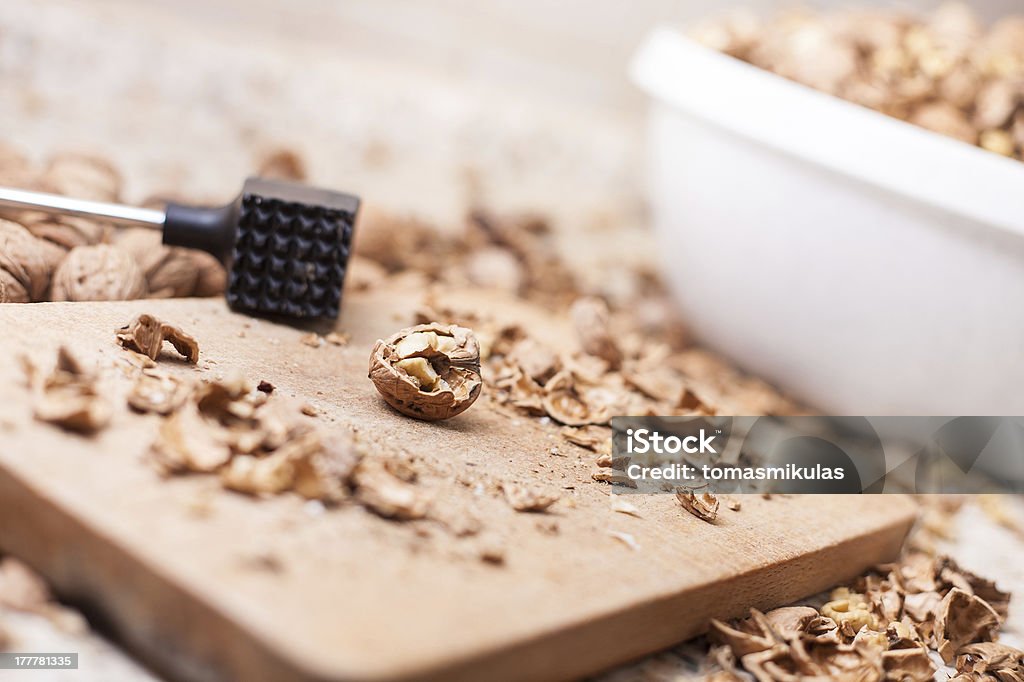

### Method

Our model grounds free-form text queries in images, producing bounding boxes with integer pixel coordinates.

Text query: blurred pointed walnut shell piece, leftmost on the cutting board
[26,346,111,434]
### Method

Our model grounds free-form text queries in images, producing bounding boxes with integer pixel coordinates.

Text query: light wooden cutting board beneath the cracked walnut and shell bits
[0,282,915,680]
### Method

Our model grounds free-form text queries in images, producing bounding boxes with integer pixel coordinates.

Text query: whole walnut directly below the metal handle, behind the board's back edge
[51,244,146,301]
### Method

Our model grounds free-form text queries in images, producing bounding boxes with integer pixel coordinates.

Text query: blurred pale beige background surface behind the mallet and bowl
[0,0,1019,294]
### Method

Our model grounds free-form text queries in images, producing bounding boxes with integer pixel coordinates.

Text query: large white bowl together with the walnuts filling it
[632,3,1024,415]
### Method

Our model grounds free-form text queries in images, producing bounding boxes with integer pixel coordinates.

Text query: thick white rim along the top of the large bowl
[630,26,1024,237]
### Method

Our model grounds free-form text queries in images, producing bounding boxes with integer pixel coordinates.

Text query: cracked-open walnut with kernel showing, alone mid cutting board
[369,323,483,421]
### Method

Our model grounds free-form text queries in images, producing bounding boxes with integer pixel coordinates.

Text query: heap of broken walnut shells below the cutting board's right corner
[709,552,1024,682]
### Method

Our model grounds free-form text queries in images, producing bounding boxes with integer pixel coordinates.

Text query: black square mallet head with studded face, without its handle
[227,178,359,317]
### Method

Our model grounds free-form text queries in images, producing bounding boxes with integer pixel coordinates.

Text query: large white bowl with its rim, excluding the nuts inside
[632,29,1024,415]
